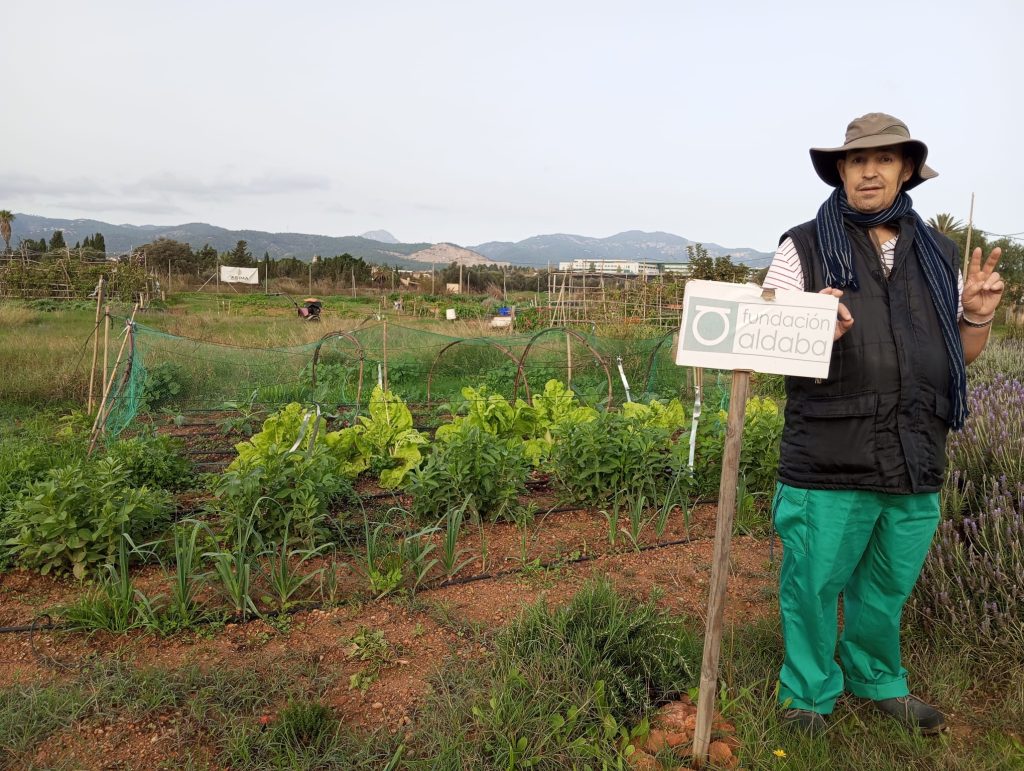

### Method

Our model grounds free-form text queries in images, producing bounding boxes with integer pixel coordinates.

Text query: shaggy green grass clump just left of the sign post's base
[403,580,700,769]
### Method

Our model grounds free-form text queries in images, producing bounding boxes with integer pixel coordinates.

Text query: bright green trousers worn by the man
[774,483,939,715]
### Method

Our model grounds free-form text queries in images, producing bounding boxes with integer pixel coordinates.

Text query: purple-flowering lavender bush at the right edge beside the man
[907,374,1024,645]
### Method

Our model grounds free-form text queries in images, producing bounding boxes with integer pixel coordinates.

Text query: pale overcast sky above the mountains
[0,0,1024,251]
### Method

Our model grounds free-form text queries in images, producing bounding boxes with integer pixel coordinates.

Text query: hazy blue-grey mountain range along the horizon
[11,214,771,268]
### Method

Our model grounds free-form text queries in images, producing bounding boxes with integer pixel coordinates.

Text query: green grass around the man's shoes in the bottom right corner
[719,618,1024,771]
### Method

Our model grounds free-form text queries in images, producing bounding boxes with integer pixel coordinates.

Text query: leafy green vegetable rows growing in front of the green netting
[3,380,781,630]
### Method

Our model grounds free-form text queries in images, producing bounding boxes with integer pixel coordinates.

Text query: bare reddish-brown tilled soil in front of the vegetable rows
[0,506,774,769]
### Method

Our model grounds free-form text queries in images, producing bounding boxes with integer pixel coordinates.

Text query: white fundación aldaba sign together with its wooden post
[676,281,839,765]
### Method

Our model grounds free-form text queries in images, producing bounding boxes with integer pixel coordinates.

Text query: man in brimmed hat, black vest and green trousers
[764,113,1002,733]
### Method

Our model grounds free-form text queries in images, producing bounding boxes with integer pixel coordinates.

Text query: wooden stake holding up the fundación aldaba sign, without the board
[693,370,751,765]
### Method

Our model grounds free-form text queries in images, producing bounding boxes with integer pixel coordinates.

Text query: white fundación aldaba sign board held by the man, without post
[676,281,839,378]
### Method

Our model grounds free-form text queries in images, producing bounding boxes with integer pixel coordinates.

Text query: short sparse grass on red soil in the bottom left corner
[0,657,397,769]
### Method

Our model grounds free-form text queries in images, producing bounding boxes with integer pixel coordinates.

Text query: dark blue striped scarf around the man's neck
[816,186,968,429]
